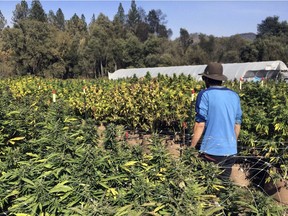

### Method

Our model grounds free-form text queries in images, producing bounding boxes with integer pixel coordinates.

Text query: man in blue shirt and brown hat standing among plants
[191,63,242,180]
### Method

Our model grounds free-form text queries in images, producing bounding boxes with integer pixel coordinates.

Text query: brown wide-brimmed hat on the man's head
[199,62,228,81]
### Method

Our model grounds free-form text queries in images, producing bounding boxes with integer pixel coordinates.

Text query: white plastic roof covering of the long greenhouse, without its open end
[108,61,288,80]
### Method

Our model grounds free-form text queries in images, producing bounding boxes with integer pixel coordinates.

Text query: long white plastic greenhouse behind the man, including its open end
[108,61,288,81]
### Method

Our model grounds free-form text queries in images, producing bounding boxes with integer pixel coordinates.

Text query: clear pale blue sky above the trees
[0,0,288,39]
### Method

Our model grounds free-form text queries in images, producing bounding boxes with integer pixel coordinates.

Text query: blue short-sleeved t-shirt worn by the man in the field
[195,86,242,156]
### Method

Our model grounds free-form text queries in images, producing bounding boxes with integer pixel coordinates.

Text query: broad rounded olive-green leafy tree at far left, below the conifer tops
[3,20,60,76]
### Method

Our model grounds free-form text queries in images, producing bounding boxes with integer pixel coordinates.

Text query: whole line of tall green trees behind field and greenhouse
[0,0,288,79]
